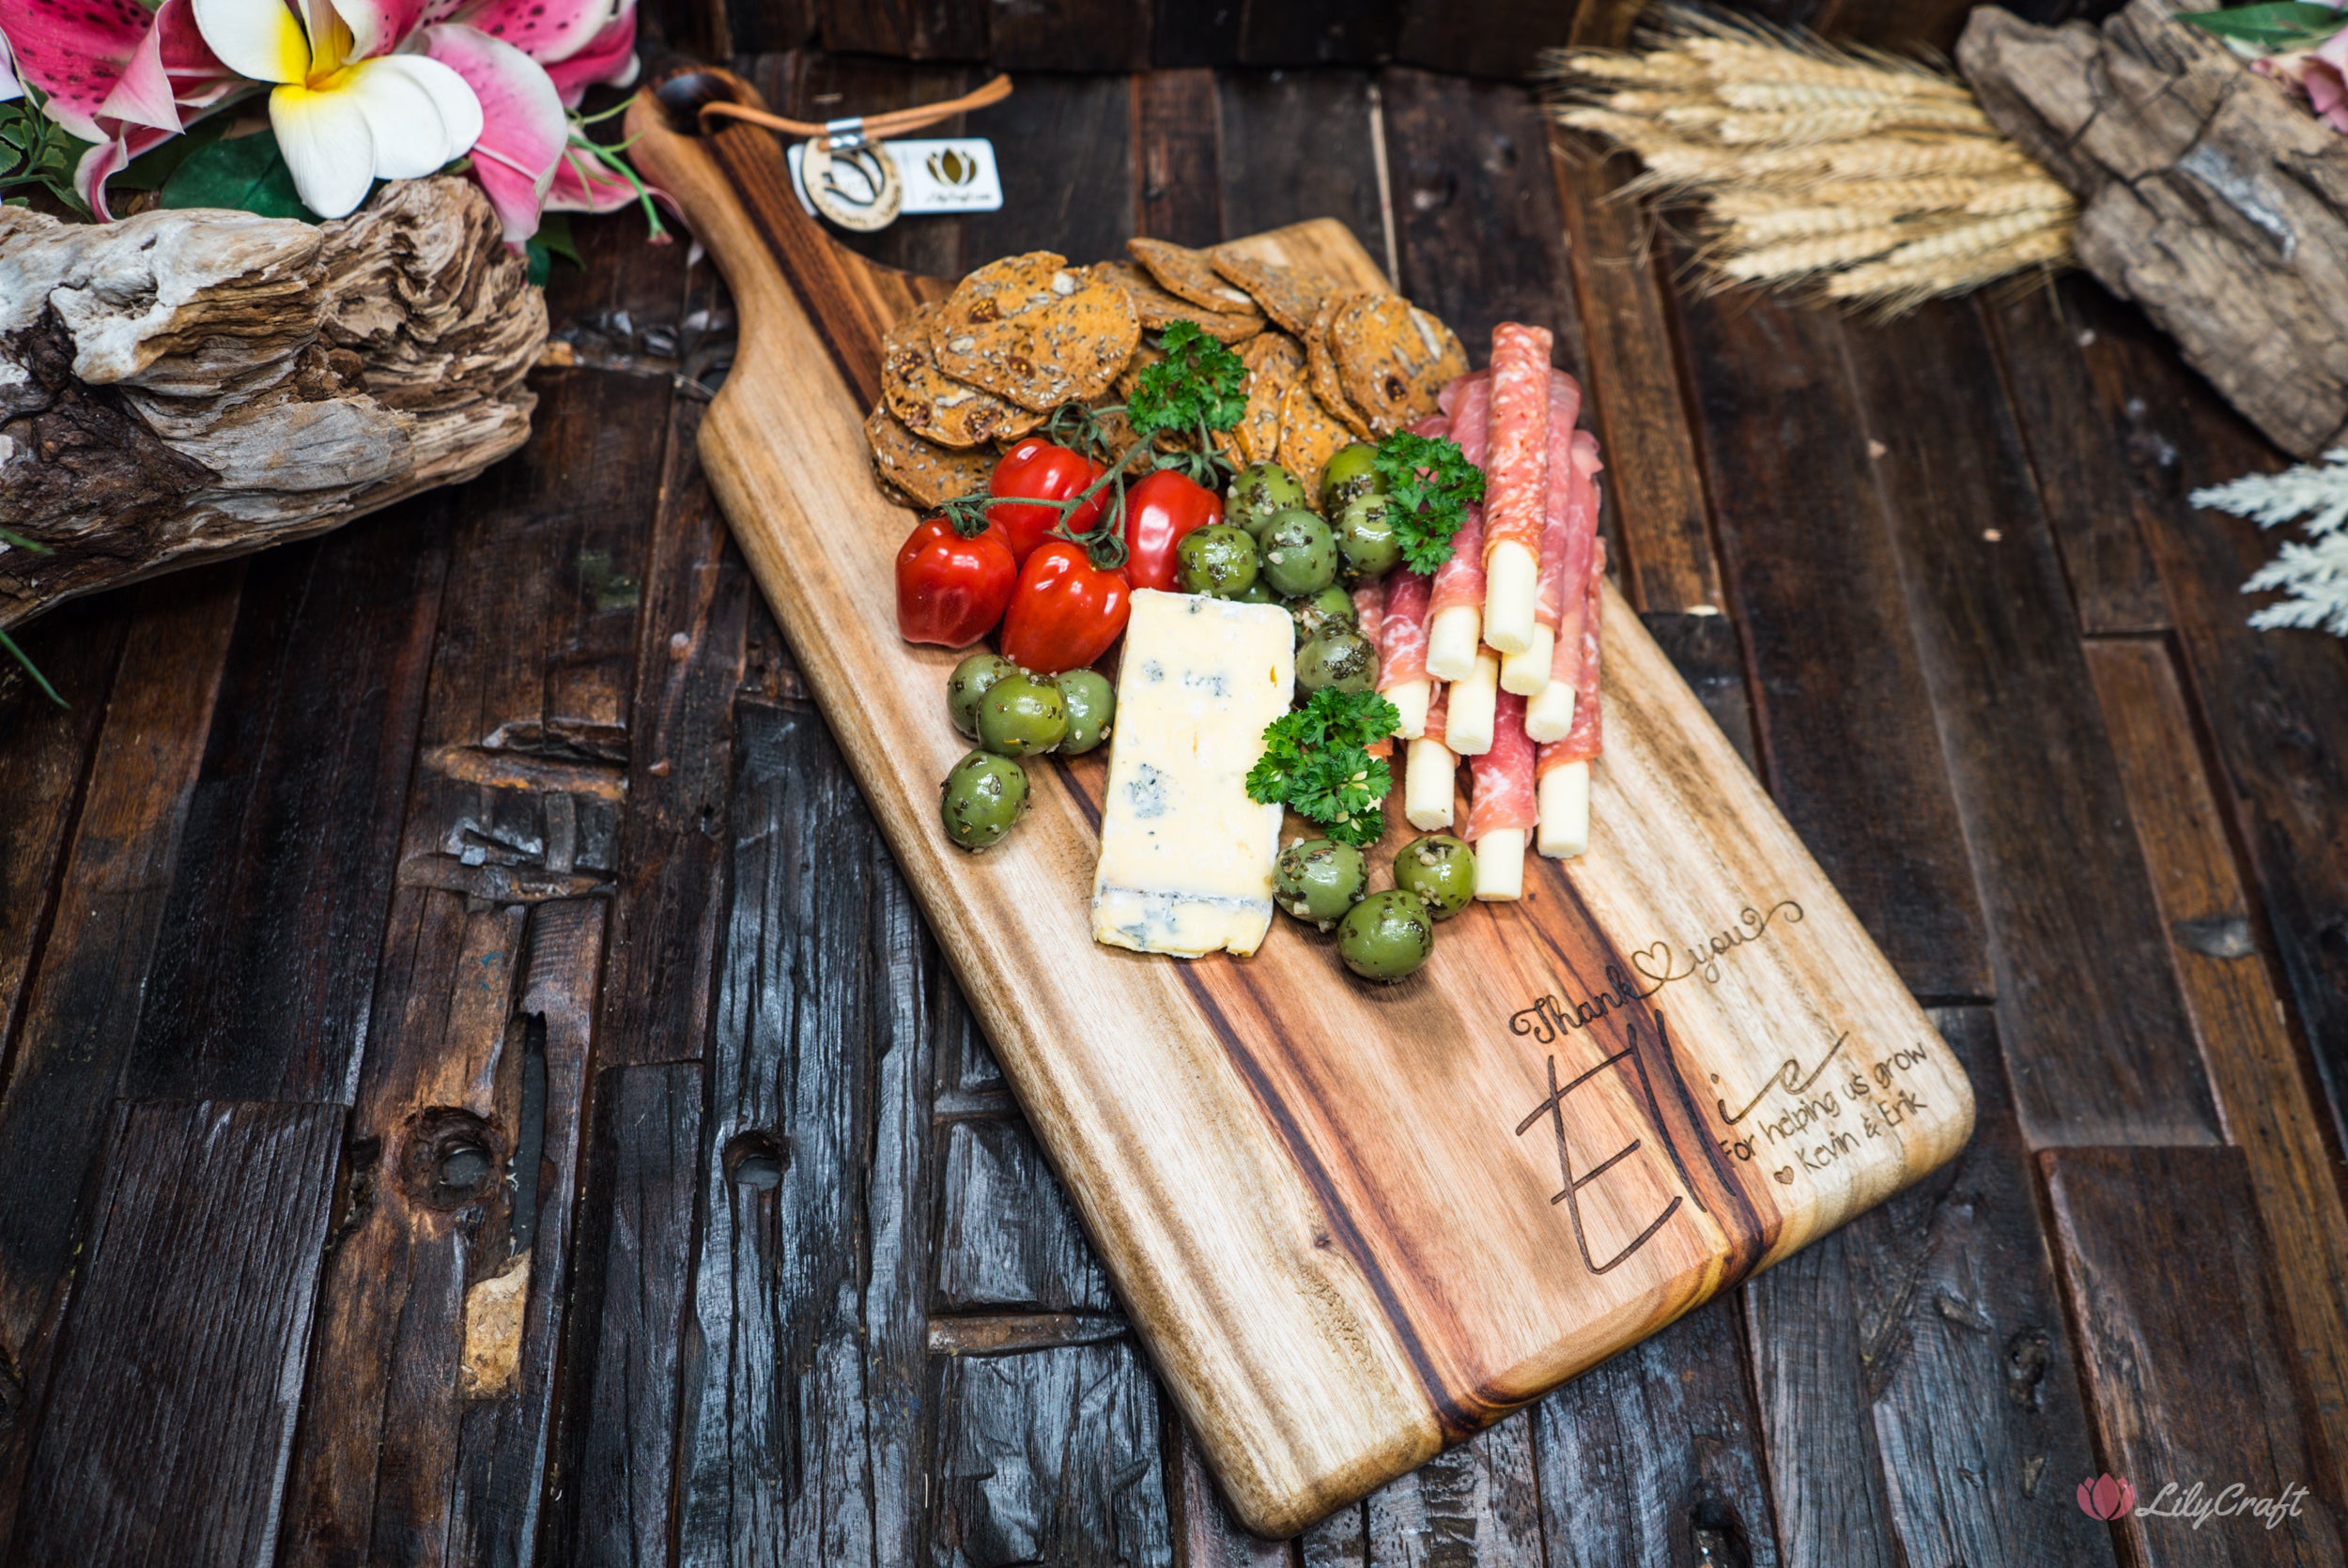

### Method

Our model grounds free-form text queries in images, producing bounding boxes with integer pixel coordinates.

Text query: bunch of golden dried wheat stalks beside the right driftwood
[1550,8,2078,315]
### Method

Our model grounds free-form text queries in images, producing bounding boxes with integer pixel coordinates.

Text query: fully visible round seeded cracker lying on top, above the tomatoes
[930,252,1141,413]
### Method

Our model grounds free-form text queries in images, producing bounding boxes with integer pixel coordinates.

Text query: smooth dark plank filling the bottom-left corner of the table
[9,1101,343,1568]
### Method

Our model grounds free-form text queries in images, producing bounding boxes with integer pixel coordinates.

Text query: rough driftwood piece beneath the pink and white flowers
[0,177,548,629]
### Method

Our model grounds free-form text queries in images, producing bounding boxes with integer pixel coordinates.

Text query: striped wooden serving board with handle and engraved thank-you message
[629,73,1972,1535]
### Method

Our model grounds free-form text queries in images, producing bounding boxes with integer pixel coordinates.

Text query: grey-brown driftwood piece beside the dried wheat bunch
[1956,0,2348,458]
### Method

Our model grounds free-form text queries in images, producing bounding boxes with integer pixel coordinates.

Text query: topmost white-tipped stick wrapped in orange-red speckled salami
[1484,322,1552,655]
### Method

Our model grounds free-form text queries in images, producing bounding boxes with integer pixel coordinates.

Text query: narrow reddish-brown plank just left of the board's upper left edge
[599,397,754,1066]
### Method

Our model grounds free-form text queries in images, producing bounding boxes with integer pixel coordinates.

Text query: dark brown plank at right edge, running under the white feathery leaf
[2083,287,2348,1145]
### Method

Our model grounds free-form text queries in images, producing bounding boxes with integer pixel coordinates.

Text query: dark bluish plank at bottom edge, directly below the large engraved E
[1534,1296,1784,1568]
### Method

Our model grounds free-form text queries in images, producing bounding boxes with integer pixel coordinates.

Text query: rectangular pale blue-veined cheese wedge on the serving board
[1092,590,1296,958]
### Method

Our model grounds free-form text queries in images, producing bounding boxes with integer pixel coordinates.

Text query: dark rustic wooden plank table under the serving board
[0,3,2348,1568]
